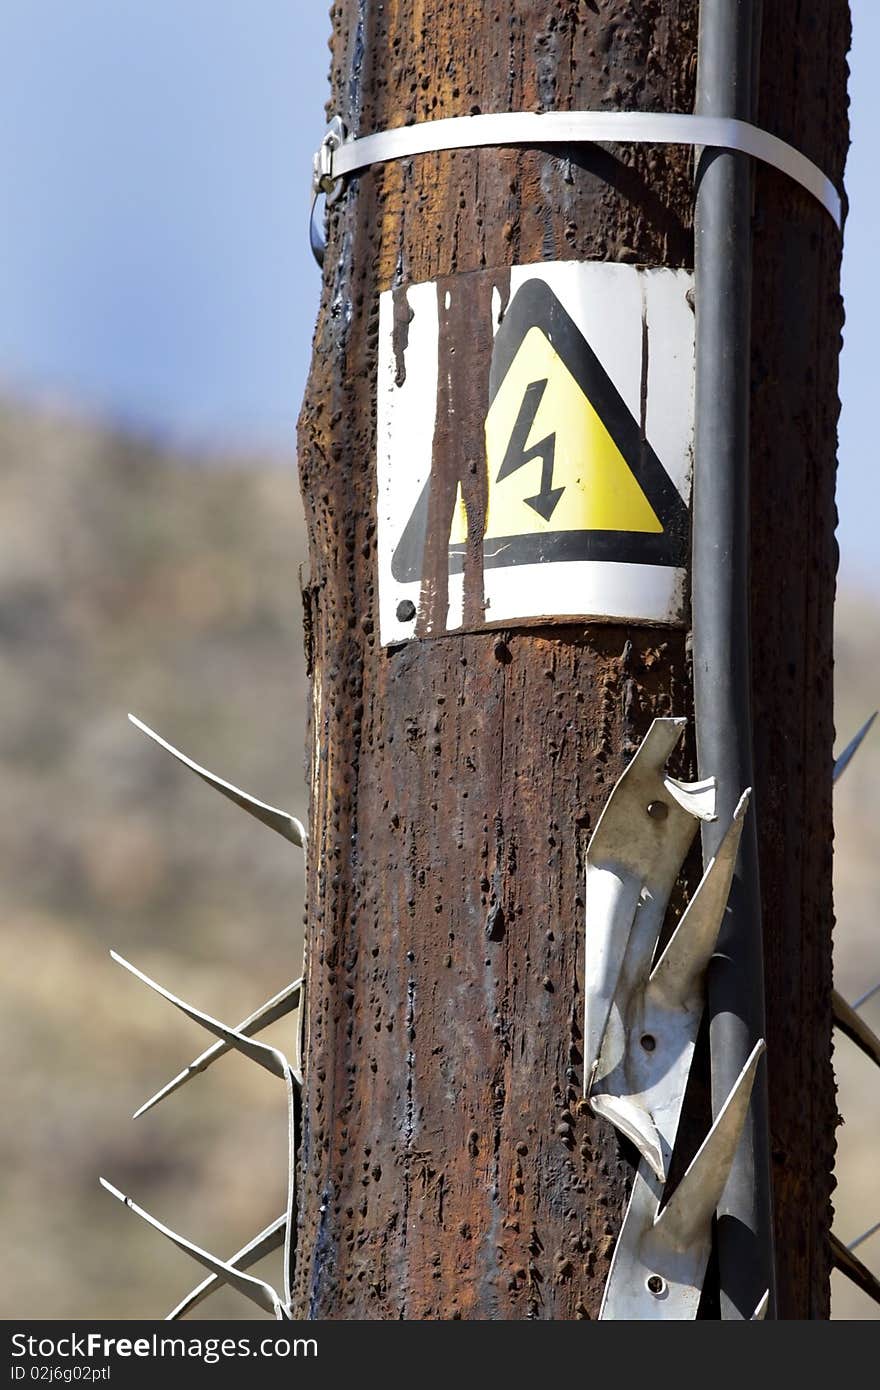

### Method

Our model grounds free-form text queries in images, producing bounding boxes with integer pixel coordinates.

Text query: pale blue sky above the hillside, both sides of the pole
[0,0,880,589]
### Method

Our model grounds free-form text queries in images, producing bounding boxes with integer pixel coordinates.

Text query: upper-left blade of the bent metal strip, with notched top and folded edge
[584,719,715,1095]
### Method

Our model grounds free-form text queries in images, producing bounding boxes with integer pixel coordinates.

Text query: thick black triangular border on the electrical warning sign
[391,278,690,584]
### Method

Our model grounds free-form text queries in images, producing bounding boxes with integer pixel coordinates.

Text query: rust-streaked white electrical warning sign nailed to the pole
[378,263,694,644]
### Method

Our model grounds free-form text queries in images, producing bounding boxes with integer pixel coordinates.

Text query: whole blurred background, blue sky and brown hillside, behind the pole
[0,0,880,1319]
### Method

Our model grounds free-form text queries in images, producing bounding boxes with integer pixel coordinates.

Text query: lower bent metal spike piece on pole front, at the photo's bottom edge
[599,1040,765,1322]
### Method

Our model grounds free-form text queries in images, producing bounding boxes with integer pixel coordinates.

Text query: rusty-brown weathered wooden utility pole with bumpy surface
[295,0,849,1319]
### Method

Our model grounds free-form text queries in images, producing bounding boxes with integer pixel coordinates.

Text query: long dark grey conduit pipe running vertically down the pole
[691,0,774,1319]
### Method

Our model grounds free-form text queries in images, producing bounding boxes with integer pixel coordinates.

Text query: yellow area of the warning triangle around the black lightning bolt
[449,327,663,545]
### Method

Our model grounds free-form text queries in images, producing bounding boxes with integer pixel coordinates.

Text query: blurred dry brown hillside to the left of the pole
[0,410,306,1319]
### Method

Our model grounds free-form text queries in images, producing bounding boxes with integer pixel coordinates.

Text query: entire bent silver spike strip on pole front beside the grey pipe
[584,719,765,1321]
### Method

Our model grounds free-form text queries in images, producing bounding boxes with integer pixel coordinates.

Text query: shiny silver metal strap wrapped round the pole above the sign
[316,111,841,228]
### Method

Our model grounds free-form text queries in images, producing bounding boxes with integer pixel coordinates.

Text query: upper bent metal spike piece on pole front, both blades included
[584,720,722,1180]
